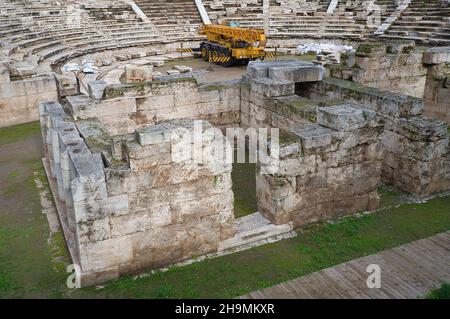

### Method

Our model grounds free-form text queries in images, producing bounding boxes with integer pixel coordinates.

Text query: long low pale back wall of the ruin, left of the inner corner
[67,75,240,135]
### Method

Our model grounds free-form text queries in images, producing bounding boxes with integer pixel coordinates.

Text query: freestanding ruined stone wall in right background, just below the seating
[329,41,427,98]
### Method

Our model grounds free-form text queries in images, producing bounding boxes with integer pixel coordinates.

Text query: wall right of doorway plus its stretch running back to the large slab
[241,61,383,227]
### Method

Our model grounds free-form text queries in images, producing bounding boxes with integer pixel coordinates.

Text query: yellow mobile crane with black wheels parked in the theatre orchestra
[200,24,266,66]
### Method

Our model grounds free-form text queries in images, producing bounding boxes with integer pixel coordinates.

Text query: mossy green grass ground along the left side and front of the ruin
[0,124,450,298]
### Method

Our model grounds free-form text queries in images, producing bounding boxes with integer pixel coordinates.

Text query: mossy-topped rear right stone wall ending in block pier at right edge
[299,78,450,197]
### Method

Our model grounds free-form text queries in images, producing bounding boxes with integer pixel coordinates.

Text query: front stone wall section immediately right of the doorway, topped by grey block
[257,104,383,227]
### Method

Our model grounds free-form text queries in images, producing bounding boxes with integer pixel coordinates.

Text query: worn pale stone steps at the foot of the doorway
[218,212,296,251]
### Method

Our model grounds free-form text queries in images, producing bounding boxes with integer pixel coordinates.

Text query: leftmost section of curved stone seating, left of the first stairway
[0,0,176,70]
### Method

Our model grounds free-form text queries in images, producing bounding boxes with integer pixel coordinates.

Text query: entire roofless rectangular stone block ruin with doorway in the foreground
[39,62,450,286]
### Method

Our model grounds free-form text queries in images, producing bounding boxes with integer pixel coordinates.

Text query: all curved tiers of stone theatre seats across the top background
[0,0,450,72]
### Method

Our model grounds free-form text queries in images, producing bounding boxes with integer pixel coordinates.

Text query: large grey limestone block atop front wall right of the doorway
[317,104,376,131]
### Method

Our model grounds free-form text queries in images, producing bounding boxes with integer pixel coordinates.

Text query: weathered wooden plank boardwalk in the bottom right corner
[241,232,450,299]
